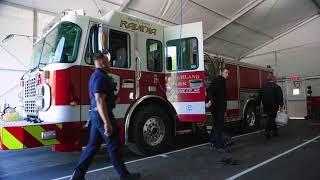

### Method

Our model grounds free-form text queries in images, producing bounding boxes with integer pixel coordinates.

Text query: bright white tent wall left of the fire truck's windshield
[0,2,54,110]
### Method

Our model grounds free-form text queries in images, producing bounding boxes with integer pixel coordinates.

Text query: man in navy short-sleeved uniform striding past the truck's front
[71,53,140,180]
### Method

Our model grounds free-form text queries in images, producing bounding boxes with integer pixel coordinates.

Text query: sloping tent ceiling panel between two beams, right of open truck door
[206,0,319,58]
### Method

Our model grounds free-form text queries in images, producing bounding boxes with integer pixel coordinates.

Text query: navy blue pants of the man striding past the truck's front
[73,111,129,179]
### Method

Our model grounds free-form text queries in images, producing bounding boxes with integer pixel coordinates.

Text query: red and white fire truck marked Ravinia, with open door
[0,11,271,154]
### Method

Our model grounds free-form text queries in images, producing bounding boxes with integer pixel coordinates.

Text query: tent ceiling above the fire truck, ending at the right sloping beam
[2,0,320,59]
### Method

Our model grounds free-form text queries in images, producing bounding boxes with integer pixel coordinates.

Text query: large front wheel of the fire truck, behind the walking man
[132,105,173,155]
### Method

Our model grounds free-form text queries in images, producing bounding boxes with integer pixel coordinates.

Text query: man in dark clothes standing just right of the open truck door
[206,69,229,152]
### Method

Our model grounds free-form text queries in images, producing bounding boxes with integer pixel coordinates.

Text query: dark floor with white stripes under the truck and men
[0,120,320,180]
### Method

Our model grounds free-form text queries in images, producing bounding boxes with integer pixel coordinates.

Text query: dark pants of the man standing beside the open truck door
[211,111,225,149]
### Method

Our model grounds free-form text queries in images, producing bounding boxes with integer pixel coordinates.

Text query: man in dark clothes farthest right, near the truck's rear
[257,73,283,139]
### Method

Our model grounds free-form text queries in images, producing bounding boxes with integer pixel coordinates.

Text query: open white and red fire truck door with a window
[164,22,205,122]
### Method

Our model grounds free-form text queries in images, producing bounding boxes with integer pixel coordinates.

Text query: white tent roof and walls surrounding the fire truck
[0,0,320,108]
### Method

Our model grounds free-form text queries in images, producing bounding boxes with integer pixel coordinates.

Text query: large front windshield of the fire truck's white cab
[31,22,81,67]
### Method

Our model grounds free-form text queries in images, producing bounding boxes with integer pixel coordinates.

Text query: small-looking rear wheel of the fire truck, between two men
[241,105,259,132]
